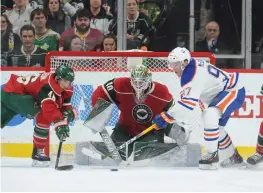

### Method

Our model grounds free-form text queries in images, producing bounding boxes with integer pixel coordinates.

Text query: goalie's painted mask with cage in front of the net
[131,65,152,99]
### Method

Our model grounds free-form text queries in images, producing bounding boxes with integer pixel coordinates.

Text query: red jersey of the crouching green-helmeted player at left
[3,73,73,122]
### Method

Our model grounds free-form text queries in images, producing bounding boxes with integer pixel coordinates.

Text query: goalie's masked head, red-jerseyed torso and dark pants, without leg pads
[92,65,176,157]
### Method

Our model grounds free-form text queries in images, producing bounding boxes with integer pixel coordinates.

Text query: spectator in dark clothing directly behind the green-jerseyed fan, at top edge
[44,0,72,35]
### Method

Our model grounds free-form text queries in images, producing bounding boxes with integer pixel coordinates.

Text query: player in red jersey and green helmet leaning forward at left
[1,65,76,165]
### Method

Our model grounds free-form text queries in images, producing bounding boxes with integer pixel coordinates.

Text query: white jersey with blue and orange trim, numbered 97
[169,58,243,126]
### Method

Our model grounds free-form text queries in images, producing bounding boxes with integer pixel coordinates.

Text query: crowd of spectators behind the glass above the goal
[1,0,263,68]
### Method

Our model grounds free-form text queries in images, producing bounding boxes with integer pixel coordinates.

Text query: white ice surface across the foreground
[1,158,263,192]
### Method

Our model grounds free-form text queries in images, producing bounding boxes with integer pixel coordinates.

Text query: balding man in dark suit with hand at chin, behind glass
[195,21,229,68]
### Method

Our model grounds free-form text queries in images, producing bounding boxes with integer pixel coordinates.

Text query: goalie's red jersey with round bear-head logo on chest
[92,78,173,136]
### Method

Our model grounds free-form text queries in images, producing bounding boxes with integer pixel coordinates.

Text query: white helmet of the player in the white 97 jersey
[168,47,191,70]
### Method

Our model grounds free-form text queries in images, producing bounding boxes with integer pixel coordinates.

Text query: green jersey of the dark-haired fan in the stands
[35,29,60,52]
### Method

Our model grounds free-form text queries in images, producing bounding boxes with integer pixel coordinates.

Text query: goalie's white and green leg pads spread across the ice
[75,142,202,167]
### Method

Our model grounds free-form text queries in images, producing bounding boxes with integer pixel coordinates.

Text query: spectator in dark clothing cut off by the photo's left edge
[1,15,21,66]
